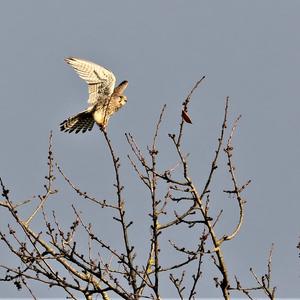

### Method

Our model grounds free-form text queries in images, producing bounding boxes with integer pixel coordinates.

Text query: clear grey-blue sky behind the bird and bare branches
[0,0,300,297]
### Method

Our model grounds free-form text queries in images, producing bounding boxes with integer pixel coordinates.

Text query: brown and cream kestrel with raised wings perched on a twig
[60,57,128,133]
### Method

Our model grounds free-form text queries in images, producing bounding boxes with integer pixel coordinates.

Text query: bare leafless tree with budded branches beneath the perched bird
[0,77,275,299]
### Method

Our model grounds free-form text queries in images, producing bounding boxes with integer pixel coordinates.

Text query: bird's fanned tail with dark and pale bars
[60,110,94,133]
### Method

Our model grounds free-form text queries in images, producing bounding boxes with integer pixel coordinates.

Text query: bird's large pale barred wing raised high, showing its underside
[65,57,116,105]
